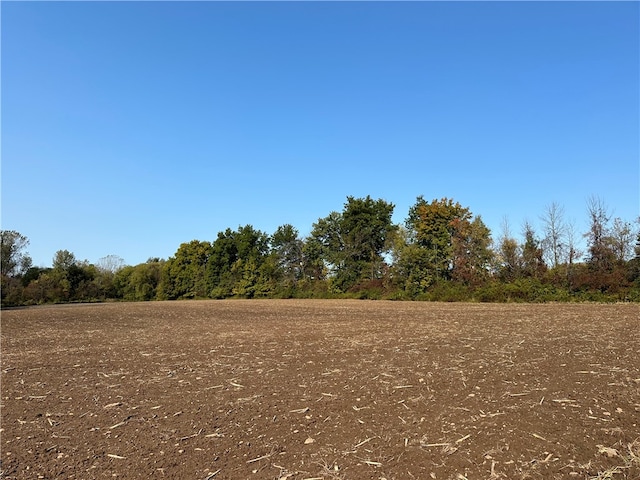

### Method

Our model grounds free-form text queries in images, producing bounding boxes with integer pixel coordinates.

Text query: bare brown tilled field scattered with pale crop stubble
[0,300,640,480]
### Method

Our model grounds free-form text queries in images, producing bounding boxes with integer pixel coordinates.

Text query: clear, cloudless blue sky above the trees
[1,1,640,266]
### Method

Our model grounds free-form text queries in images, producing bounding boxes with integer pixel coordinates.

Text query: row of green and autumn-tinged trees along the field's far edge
[1,196,640,306]
